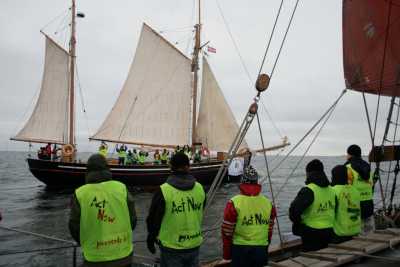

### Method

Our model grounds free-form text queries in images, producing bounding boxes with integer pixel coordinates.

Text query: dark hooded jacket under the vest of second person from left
[146,172,206,251]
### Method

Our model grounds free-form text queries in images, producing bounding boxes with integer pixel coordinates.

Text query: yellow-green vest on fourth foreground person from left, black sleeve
[301,183,335,229]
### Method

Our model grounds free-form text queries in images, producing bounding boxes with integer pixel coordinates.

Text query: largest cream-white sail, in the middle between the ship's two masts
[91,24,192,146]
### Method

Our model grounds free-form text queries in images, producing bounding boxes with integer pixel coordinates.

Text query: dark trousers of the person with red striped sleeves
[231,245,268,267]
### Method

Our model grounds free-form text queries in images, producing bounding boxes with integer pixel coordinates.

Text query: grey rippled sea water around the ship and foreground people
[0,152,396,266]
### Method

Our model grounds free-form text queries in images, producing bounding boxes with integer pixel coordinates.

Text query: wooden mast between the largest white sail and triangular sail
[192,0,201,148]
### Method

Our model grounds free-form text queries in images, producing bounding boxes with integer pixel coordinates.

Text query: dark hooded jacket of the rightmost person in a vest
[345,156,374,219]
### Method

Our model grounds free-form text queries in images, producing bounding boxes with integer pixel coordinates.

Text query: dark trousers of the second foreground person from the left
[160,248,199,267]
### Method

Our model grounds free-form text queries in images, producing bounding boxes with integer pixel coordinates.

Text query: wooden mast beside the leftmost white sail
[68,0,76,145]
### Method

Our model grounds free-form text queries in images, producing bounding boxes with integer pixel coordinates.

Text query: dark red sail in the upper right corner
[343,0,400,96]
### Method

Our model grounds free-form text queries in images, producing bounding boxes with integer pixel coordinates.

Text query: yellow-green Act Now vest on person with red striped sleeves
[231,195,272,246]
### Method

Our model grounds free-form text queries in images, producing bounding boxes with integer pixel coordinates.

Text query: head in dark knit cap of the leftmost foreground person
[85,154,112,183]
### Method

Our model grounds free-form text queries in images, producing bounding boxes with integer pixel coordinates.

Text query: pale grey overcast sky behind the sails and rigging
[0,0,389,155]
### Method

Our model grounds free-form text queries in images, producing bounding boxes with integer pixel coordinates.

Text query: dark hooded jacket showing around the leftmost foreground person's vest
[68,158,137,267]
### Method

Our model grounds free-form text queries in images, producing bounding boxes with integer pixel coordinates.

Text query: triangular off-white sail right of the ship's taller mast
[196,58,247,151]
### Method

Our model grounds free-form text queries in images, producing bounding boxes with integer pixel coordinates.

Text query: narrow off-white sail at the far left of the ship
[11,36,69,144]
